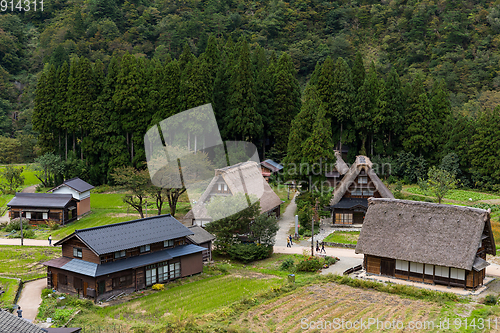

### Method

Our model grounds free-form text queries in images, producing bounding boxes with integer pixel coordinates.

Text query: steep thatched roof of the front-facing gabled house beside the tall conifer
[330,156,394,206]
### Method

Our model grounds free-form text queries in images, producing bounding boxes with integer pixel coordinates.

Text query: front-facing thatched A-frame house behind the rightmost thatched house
[329,156,394,224]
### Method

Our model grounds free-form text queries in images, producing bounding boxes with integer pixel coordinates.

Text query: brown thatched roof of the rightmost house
[356,198,496,271]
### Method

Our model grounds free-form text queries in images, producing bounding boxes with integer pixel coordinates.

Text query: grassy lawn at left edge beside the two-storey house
[0,245,61,281]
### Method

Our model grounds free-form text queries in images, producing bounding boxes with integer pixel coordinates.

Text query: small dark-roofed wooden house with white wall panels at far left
[7,192,77,225]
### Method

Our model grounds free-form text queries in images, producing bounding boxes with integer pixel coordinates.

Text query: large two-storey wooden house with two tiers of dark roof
[44,215,206,300]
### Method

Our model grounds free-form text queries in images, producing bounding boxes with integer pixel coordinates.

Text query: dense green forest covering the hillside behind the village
[0,0,500,189]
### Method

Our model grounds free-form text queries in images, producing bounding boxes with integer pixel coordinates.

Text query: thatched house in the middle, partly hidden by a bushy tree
[184,161,282,227]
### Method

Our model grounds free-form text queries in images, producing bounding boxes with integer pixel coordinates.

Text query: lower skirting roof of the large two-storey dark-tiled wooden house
[43,244,206,277]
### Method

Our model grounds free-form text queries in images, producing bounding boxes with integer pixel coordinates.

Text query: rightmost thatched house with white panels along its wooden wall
[356,198,496,288]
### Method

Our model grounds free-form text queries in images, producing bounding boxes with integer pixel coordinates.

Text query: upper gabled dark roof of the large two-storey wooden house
[60,214,193,255]
